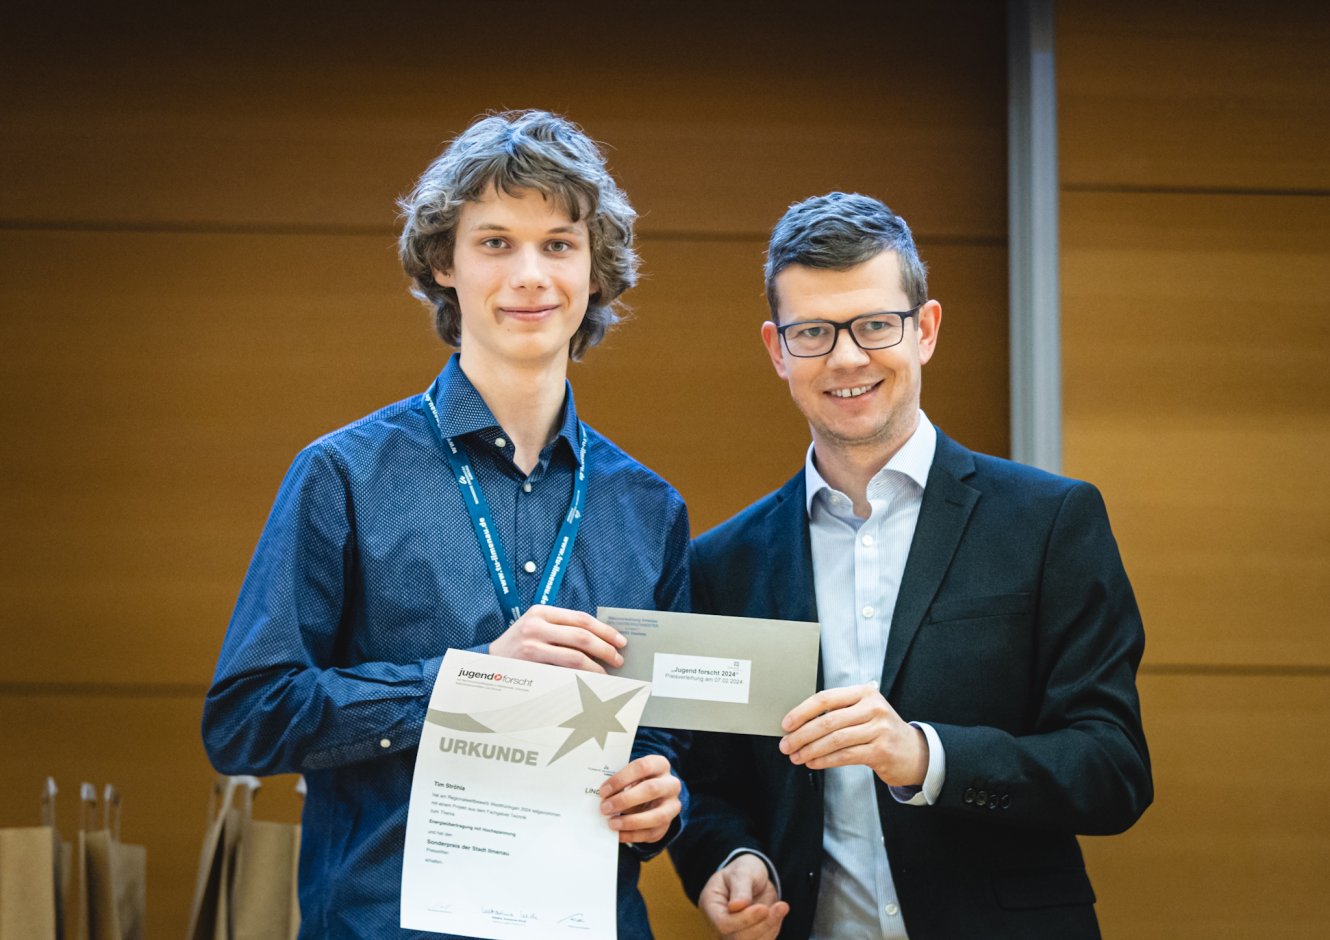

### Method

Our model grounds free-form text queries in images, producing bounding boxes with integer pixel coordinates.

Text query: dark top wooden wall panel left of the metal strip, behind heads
[0,0,1007,241]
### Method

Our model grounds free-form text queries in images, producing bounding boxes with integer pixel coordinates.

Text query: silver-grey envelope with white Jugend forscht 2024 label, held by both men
[596,608,821,735]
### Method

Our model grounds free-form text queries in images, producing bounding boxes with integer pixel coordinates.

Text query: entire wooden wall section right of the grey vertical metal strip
[1056,0,1330,939]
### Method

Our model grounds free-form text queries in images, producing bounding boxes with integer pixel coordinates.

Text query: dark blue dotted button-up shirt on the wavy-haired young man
[203,356,689,940]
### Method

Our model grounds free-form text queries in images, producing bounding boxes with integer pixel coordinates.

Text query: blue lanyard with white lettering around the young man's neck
[422,392,587,625]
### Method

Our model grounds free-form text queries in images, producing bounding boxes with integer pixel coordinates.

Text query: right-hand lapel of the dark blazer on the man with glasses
[879,431,979,697]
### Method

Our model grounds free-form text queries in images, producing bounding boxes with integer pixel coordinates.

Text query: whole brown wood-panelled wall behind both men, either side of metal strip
[0,0,1330,940]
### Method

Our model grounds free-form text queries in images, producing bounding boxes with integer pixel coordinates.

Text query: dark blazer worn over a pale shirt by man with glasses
[670,431,1153,940]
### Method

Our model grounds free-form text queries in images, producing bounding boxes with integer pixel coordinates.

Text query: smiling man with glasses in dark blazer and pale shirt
[670,193,1153,940]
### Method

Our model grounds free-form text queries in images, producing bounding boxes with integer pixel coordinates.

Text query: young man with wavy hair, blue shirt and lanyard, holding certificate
[203,112,689,940]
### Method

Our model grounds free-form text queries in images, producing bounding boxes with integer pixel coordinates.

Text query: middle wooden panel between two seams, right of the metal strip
[1063,193,1330,666]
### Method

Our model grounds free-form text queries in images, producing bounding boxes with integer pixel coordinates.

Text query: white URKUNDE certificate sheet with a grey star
[402,650,649,940]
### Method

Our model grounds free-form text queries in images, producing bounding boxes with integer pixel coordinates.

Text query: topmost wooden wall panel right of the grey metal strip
[1057,0,1330,195]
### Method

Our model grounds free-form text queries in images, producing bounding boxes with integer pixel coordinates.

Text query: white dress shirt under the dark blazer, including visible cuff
[805,411,946,940]
